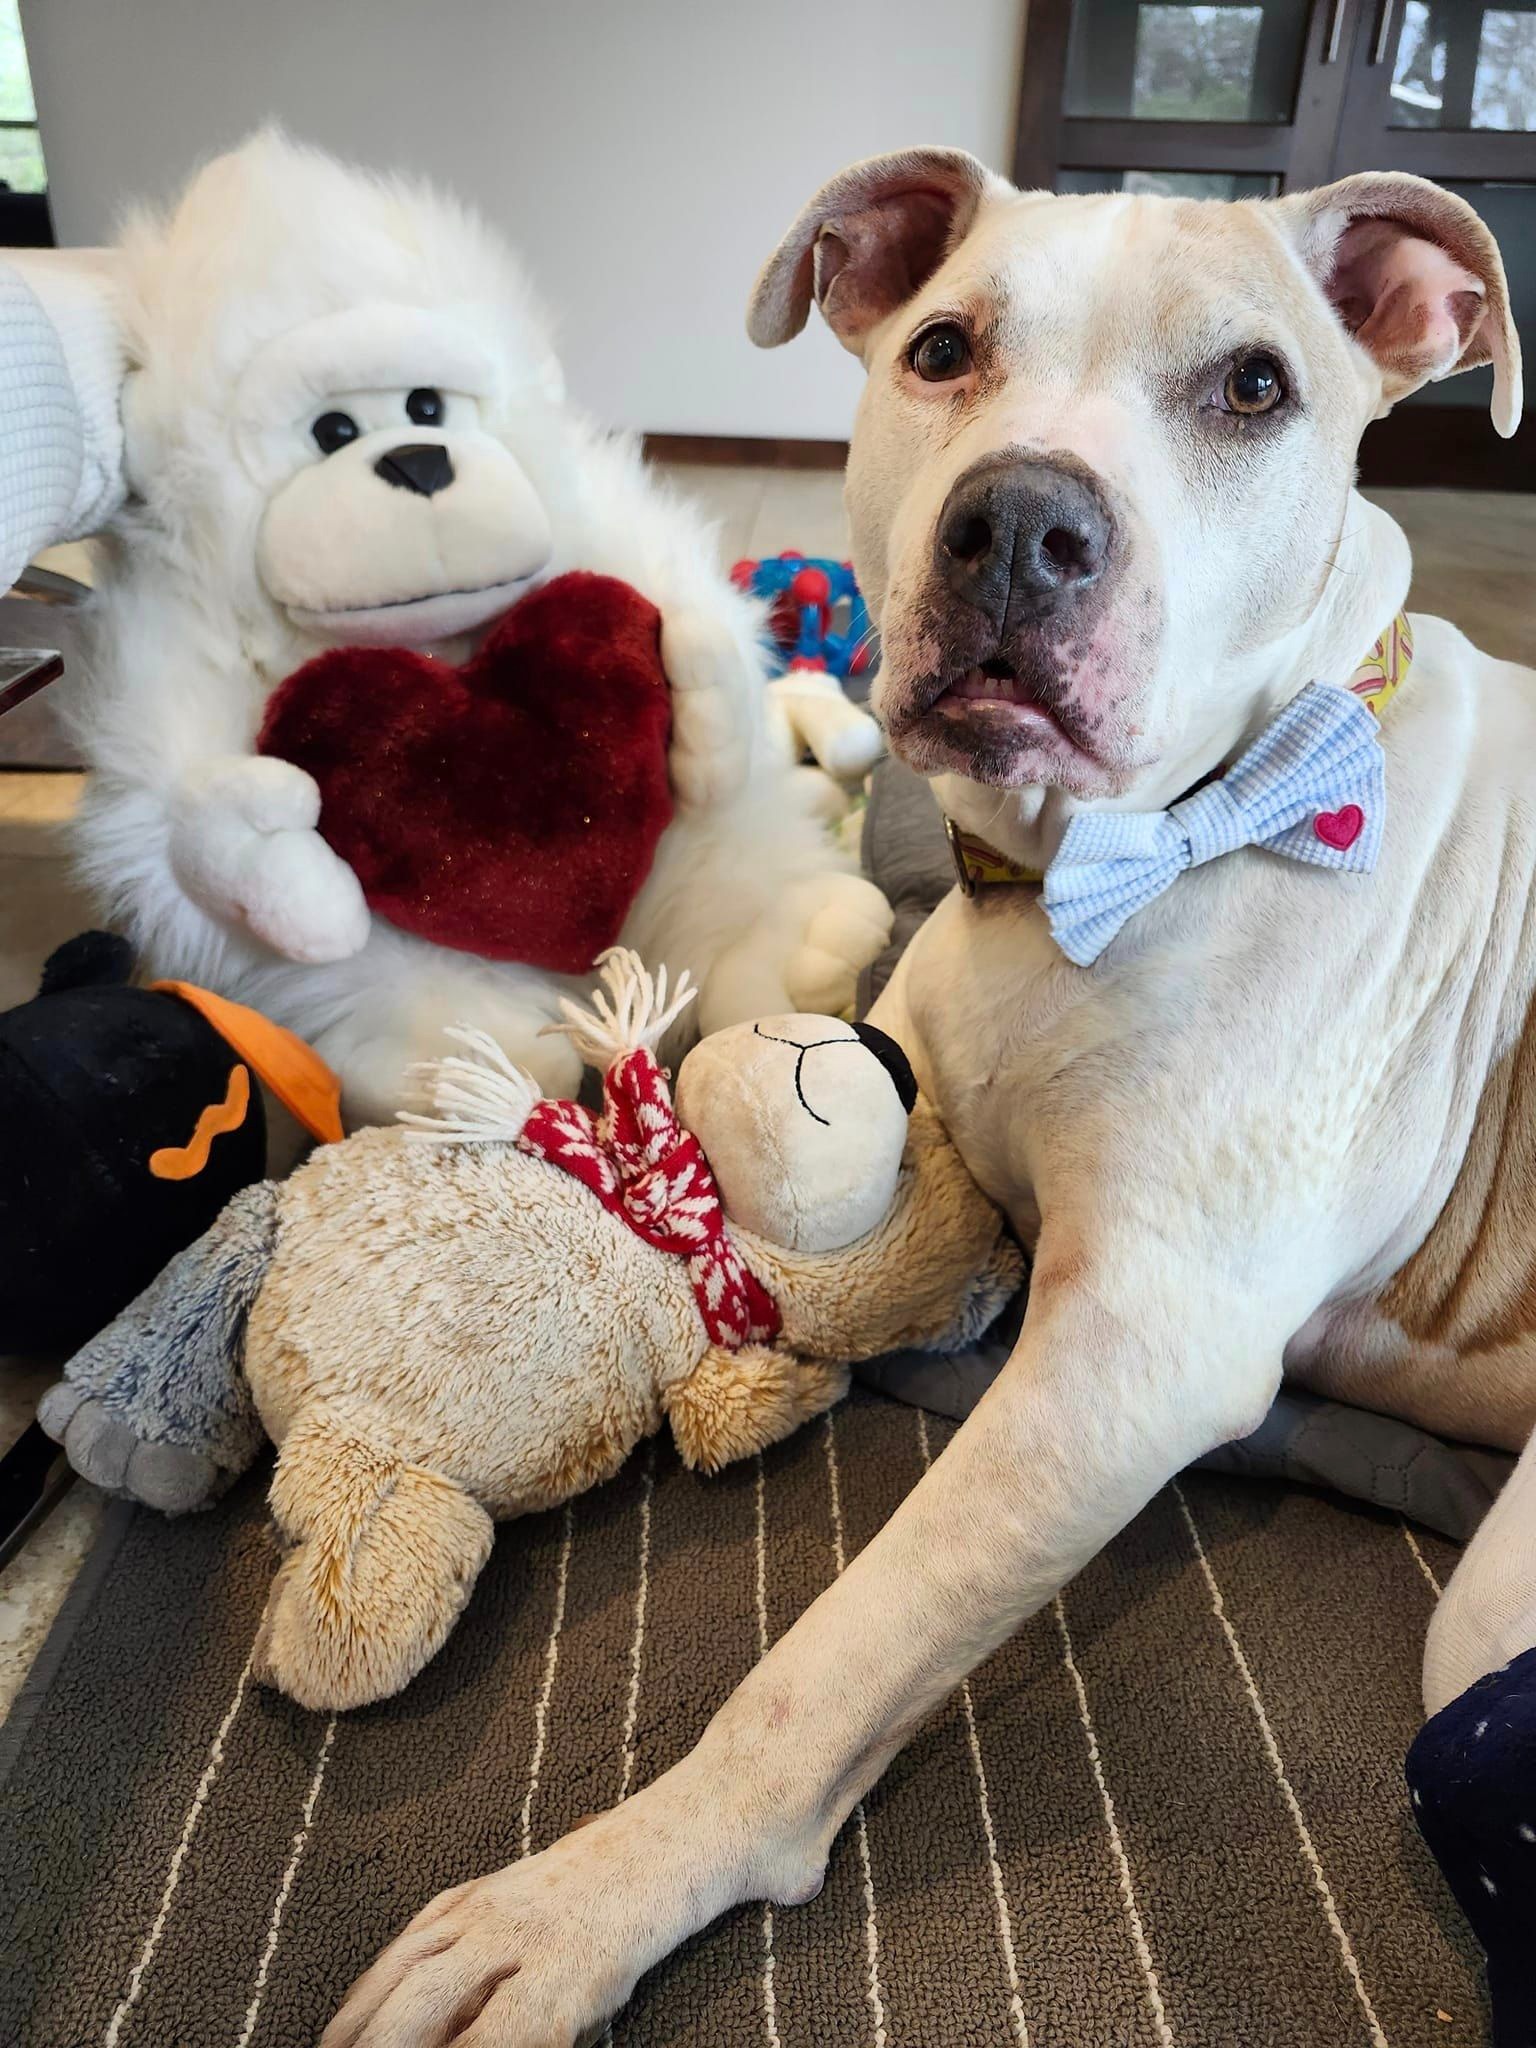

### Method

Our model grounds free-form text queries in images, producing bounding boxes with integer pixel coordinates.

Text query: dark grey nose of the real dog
[934,457,1112,633]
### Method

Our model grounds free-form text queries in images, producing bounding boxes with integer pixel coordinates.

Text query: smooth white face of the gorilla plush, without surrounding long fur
[236,303,551,645]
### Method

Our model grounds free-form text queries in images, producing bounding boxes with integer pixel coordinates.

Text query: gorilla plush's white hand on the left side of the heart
[170,756,369,965]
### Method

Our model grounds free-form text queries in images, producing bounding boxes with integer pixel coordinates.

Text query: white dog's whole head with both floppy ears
[748,150,1520,801]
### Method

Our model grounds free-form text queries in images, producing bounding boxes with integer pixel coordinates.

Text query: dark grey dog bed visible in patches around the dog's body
[858,760,1513,1542]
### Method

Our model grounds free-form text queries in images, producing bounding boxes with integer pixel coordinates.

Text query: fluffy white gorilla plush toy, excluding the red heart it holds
[51,133,889,1122]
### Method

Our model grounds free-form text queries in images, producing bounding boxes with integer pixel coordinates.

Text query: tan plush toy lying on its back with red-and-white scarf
[39,954,1022,1710]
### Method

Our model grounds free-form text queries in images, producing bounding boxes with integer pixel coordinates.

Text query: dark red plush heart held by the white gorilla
[256,571,672,975]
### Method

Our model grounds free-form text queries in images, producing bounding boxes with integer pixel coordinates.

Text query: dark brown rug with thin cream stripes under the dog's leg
[0,1397,1487,2048]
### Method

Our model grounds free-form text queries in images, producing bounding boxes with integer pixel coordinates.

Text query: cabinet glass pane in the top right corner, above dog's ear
[1391,0,1536,133]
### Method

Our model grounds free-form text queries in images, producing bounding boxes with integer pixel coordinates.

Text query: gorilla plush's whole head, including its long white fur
[123,133,561,645]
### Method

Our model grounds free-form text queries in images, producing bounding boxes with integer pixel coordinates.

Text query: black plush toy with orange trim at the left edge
[0,932,342,1354]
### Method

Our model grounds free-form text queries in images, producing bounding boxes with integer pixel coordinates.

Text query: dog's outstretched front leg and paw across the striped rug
[324,1233,1284,2048]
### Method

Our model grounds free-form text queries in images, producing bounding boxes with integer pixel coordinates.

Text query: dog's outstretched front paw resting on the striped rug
[322,1794,692,2048]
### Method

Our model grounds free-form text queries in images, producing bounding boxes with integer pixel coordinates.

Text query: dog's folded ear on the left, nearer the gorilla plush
[748,150,1010,354]
